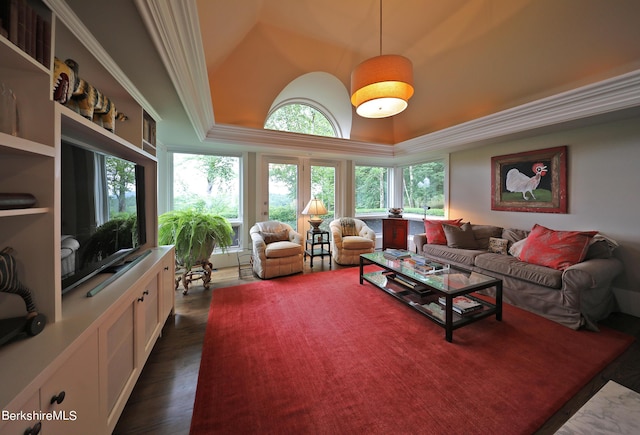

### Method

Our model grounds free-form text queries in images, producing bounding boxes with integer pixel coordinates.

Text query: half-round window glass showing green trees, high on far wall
[264,103,337,137]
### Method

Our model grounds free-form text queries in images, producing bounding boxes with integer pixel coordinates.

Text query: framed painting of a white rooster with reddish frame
[491,146,567,213]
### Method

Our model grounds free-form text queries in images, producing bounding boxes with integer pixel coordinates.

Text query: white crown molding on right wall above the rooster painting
[395,70,640,156]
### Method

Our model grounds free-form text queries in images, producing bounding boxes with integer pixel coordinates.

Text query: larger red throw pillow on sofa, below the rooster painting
[520,224,598,270]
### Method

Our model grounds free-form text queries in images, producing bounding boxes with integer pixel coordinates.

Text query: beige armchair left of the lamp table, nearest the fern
[249,221,304,279]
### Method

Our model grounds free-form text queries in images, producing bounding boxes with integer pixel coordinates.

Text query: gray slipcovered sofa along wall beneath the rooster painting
[414,224,623,331]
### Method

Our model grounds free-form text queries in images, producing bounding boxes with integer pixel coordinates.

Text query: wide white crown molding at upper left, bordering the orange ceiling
[136,0,215,140]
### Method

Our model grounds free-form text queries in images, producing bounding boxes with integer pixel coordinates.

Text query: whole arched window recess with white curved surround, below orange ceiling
[264,72,353,139]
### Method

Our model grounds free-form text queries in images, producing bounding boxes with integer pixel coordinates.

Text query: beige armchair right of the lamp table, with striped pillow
[329,218,376,265]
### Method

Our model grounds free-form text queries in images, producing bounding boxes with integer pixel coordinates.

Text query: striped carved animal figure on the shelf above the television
[52,57,129,133]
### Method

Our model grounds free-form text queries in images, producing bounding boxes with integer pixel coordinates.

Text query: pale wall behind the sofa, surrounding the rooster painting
[450,118,640,316]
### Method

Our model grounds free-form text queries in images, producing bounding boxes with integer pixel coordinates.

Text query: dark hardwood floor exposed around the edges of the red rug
[114,258,640,435]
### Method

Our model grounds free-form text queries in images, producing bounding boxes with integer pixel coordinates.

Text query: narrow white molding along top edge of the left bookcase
[43,0,162,121]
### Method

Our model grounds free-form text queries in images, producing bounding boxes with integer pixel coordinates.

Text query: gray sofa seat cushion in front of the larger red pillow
[475,253,562,289]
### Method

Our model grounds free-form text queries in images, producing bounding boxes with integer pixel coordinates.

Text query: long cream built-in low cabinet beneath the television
[0,246,175,435]
